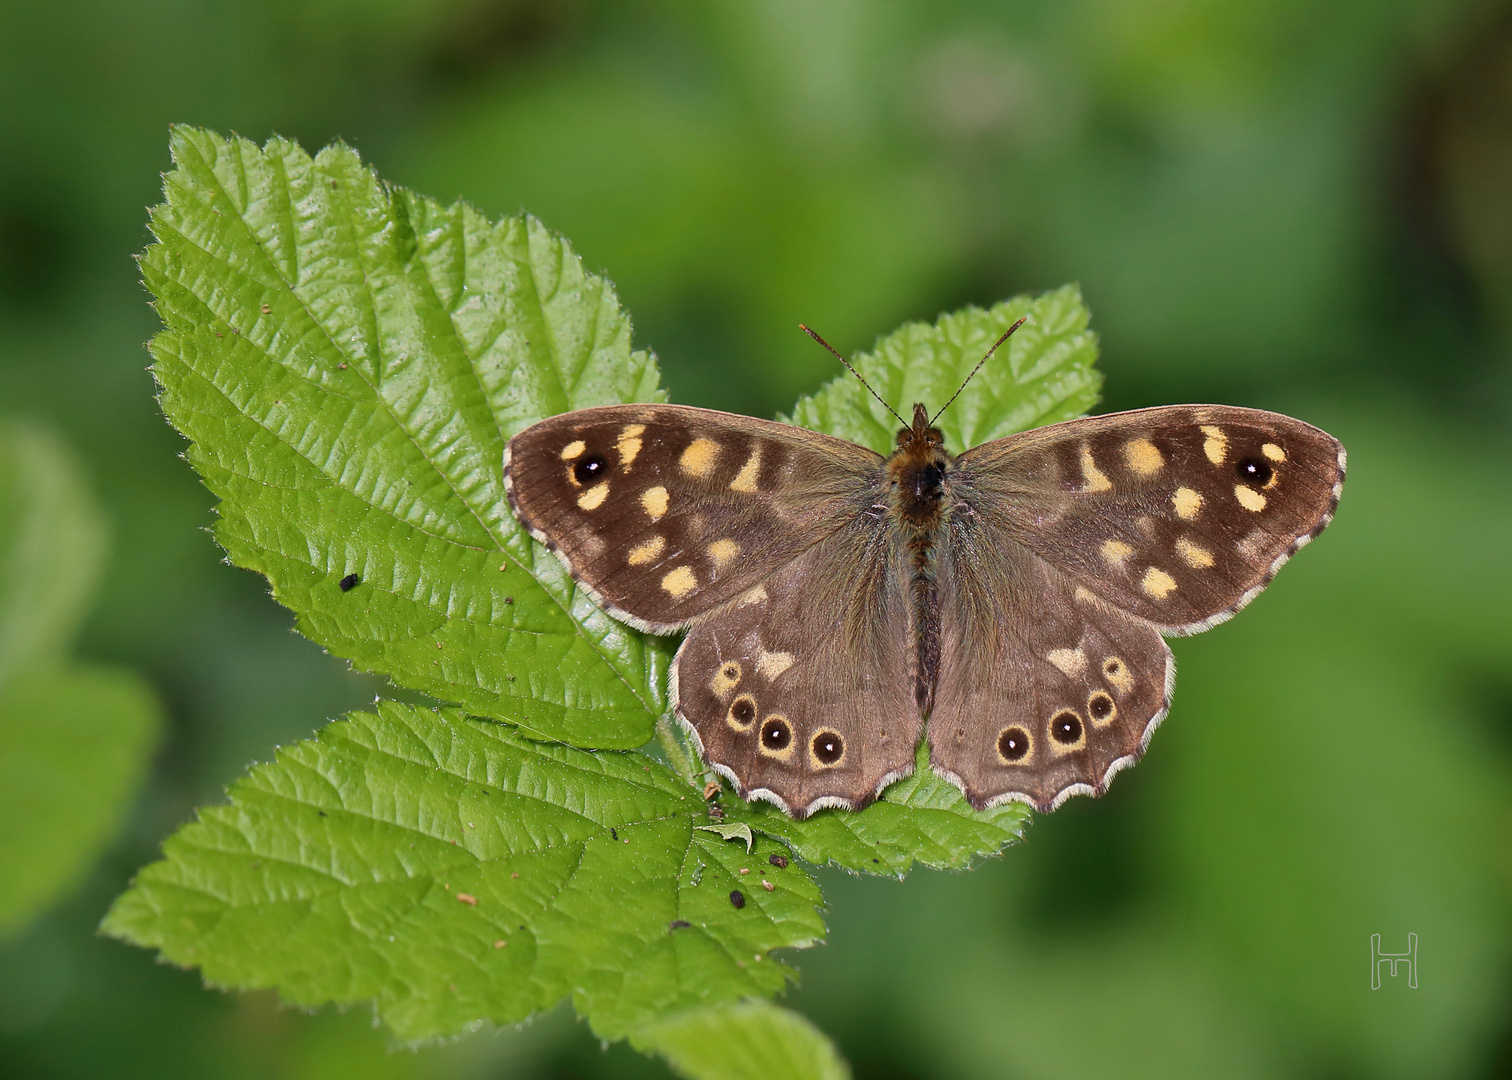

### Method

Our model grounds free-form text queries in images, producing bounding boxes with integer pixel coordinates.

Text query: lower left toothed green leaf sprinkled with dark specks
[103,703,824,1039]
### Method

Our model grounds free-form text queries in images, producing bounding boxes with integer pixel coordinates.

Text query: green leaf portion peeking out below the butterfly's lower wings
[726,743,1030,877]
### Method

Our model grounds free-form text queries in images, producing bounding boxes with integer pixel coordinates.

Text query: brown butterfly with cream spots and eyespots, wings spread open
[503,319,1344,818]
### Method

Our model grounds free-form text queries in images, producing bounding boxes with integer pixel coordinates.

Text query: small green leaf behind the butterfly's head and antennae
[785,284,1102,454]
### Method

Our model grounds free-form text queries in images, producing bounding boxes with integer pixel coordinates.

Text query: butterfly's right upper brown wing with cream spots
[947,405,1344,634]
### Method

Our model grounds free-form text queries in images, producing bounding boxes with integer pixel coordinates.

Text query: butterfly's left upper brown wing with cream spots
[503,405,883,634]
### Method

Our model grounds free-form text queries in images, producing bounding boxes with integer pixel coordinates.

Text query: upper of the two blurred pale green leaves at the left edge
[0,424,107,684]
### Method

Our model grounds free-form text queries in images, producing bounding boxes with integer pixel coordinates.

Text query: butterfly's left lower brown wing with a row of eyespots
[673,514,921,818]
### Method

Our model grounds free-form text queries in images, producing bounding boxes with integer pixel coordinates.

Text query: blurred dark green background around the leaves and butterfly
[0,0,1512,1080]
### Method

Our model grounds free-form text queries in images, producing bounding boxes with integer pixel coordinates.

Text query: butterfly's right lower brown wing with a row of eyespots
[928,526,1175,812]
